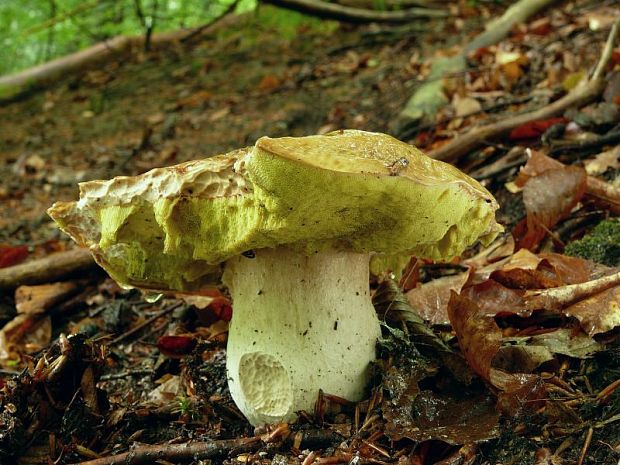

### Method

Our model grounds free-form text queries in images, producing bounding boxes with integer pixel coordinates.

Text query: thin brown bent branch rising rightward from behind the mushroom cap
[430,19,620,163]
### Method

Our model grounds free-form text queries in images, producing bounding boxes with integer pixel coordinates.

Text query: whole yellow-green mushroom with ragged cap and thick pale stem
[49,130,501,425]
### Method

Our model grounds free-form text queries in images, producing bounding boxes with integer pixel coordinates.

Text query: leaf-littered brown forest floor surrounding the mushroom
[0,1,620,465]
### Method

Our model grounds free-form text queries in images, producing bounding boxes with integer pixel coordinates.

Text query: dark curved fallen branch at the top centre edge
[263,0,448,23]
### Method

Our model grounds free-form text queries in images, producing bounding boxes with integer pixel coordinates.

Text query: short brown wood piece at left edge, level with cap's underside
[0,249,96,290]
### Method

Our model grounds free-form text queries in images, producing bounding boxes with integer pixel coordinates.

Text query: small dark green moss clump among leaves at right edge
[565,218,620,266]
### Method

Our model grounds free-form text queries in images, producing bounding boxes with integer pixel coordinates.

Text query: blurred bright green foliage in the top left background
[0,0,256,75]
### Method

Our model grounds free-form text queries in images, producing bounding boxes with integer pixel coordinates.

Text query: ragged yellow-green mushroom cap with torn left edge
[49,130,501,291]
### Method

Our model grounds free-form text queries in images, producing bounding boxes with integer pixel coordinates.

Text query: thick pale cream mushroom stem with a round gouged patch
[224,248,380,425]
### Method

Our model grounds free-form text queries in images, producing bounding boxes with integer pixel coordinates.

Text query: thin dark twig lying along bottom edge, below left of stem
[76,437,263,465]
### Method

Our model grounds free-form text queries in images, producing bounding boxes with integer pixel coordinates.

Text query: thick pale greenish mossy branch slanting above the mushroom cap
[393,0,555,132]
